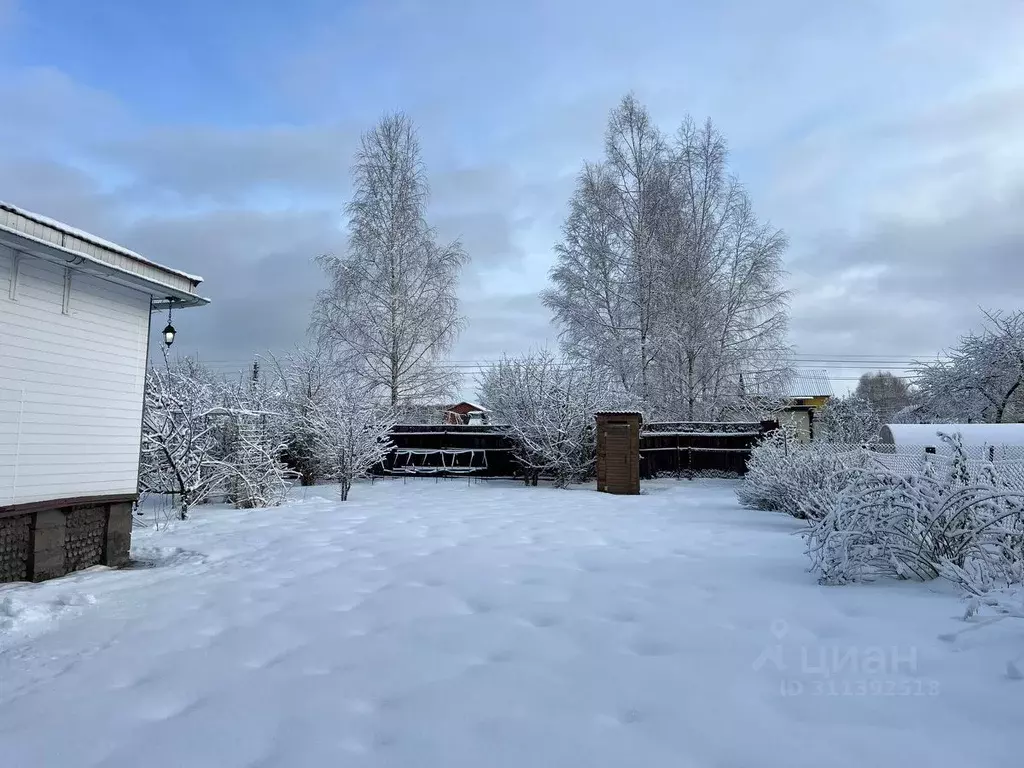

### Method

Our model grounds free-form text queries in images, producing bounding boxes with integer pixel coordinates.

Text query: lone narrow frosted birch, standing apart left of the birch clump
[311,114,466,406]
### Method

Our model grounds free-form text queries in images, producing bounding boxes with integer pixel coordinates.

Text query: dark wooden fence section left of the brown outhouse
[375,424,519,477]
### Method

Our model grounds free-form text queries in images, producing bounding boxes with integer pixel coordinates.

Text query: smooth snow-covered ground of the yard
[0,480,1024,768]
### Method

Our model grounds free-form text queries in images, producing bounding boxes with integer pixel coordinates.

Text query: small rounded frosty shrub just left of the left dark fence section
[304,381,395,501]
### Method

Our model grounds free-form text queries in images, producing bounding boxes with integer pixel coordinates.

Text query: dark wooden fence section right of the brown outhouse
[640,422,778,478]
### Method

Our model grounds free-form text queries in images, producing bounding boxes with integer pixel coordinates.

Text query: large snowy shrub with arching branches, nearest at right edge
[805,436,1024,596]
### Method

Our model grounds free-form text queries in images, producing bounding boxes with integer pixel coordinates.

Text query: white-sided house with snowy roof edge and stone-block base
[0,203,207,582]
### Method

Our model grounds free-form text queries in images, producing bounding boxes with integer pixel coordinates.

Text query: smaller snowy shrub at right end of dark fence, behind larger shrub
[736,429,859,519]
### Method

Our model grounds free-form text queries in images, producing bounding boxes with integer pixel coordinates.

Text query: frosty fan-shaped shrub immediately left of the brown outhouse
[479,351,608,487]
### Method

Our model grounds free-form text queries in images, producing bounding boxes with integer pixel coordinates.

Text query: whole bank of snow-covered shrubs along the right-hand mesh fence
[738,433,1024,616]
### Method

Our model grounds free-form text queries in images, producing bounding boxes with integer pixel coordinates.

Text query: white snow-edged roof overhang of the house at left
[0,201,209,307]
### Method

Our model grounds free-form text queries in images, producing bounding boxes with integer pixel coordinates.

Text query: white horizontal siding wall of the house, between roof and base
[0,246,150,507]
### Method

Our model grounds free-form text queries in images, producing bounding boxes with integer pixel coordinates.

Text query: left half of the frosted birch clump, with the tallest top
[543,94,669,401]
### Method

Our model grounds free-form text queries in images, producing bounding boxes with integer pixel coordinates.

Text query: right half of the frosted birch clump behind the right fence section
[657,119,787,421]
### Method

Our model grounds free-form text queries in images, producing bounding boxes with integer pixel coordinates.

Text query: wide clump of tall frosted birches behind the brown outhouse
[543,95,787,421]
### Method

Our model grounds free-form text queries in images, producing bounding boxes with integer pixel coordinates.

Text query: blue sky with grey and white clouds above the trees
[0,0,1024,387]
